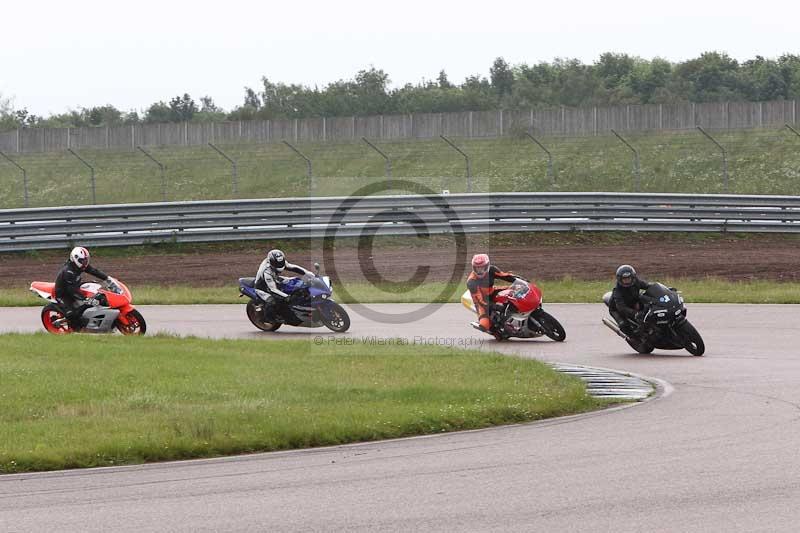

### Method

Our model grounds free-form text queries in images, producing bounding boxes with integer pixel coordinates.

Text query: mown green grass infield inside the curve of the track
[0,334,607,473]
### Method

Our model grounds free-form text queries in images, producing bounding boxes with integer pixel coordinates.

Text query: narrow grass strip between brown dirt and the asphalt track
[7,278,800,307]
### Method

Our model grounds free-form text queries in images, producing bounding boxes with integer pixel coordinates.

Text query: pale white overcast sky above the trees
[0,0,800,115]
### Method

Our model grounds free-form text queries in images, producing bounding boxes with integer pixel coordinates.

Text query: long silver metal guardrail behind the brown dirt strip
[0,193,800,251]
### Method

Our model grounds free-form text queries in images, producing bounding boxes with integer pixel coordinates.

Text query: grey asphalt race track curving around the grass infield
[0,304,800,532]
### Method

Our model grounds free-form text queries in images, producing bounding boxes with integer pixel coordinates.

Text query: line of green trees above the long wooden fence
[0,52,800,129]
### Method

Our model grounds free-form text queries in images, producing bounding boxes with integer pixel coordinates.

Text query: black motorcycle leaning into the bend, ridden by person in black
[603,283,706,355]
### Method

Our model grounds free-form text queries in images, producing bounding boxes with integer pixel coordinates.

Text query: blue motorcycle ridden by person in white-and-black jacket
[239,263,350,333]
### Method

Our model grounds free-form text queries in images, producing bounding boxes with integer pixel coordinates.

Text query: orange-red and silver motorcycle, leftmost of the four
[30,278,147,335]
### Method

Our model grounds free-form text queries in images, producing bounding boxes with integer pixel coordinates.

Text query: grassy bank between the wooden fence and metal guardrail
[0,129,800,208]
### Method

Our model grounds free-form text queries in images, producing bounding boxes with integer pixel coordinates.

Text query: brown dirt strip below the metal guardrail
[0,233,800,288]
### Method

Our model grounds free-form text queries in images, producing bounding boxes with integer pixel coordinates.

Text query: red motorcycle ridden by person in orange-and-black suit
[461,278,567,342]
